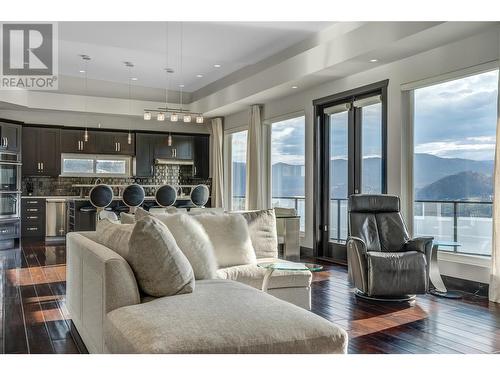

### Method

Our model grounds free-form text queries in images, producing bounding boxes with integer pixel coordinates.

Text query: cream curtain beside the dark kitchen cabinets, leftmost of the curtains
[211,117,224,207]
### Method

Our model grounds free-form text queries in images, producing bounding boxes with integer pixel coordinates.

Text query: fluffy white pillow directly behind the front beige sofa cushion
[143,214,217,280]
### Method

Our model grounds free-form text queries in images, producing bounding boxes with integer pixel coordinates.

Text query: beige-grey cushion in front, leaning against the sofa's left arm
[125,217,194,297]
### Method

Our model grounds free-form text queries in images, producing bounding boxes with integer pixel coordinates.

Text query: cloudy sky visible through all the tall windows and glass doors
[233,70,498,165]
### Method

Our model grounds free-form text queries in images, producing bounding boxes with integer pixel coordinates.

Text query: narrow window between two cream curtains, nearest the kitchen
[231,130,248,211]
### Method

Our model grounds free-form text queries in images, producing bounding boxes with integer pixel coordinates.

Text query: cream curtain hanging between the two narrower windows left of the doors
[246,105,265,210]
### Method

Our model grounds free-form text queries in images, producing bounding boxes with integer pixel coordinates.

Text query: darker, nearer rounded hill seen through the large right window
[415,171,493,201]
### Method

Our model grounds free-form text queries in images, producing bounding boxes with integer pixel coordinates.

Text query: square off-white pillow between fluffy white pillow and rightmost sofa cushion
[192,214,257,268]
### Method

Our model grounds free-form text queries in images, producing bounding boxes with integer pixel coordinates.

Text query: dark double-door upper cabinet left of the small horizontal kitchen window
[22,127,61,176]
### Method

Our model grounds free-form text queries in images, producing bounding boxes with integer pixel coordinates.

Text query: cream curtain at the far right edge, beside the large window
[489,64,500,303]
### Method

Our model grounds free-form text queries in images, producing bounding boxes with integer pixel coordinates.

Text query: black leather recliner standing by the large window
[347,194,433,300]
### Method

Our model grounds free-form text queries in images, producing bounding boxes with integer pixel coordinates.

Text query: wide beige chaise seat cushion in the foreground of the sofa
[104,280,347,354]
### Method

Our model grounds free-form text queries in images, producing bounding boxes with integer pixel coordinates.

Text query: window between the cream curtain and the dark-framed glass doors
[271,116,305,231]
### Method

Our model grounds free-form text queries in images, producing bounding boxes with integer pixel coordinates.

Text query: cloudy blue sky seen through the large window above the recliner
[414,70,498,160]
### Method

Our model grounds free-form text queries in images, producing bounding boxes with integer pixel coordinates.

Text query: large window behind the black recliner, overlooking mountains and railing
[413,70,498,255]
